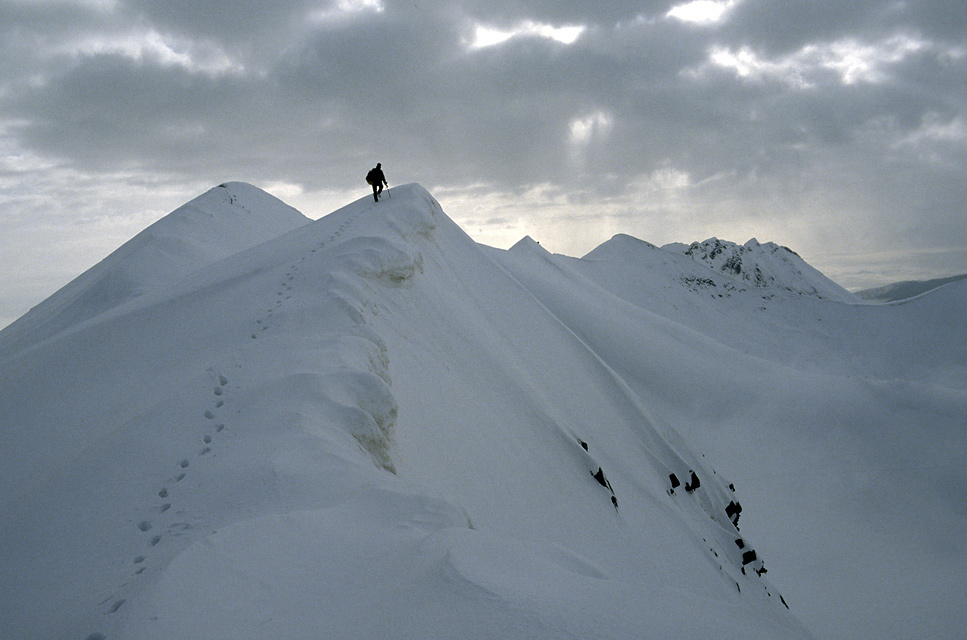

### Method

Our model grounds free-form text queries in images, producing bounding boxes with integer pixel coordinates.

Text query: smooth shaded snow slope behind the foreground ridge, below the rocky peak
[495,236,967,639]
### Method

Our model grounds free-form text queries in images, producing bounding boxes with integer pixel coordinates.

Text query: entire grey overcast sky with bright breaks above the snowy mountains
[0,0,967,326]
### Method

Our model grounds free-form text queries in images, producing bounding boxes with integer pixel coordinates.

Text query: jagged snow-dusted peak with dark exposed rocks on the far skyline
[663,238,857,302]
